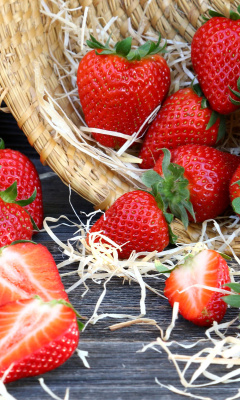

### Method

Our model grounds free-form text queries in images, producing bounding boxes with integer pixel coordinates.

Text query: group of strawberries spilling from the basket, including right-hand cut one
[77,6,240,325]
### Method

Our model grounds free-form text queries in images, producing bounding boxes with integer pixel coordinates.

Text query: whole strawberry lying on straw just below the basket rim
[87,190,169,258]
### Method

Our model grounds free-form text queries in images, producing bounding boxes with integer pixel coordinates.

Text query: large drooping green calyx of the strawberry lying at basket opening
[142,149,195,229]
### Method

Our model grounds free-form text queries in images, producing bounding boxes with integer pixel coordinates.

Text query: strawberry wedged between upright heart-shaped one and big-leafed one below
[139,85,225,168]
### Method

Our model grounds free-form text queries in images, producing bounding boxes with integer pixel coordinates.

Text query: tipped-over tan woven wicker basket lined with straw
[0,0,239,250]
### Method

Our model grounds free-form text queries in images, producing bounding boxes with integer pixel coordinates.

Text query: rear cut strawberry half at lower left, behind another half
[0,242,68,305]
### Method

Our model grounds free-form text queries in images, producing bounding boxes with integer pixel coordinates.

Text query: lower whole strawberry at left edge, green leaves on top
[0,182,37,247]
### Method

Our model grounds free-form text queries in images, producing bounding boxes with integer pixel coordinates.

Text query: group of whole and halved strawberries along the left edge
[0,141,79,383]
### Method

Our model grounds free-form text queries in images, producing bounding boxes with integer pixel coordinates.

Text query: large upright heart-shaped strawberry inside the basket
[77,36,170,148]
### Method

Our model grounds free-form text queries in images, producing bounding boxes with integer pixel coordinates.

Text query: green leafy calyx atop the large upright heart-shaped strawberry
[87,35,167,61]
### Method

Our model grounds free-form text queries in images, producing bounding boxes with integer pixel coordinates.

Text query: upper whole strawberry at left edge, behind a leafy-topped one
[0,140,43,229]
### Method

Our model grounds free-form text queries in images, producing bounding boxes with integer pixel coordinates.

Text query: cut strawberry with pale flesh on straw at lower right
[164,250,230,326]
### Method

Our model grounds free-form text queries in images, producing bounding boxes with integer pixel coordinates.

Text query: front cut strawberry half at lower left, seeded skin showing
[0,299,79,383]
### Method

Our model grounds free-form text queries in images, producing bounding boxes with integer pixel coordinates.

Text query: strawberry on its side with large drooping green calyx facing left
[143,145,240,227]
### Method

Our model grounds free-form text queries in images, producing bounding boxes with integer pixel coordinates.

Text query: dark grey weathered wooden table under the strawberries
[0,113,239,400]
